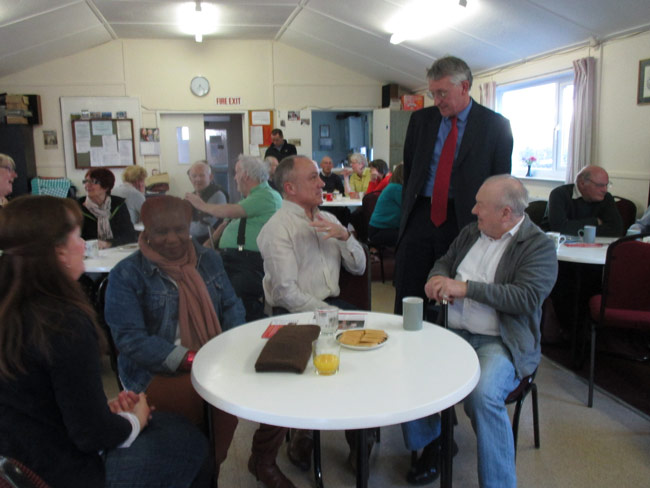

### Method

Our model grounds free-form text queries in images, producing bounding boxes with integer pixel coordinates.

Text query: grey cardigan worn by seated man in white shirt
[429,215,557,378]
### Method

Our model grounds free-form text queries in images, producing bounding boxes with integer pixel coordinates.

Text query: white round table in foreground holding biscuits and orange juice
[192,312,480,486]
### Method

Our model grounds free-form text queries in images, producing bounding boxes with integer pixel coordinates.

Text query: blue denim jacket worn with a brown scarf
[104,241,245,392]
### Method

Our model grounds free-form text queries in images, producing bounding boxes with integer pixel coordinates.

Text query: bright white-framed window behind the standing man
[497,72,573,180]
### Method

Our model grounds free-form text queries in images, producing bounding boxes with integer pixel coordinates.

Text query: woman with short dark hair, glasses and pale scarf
[79,168,138,249]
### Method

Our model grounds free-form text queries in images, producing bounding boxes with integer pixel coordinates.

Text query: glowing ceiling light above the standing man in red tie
[386,0,478,44]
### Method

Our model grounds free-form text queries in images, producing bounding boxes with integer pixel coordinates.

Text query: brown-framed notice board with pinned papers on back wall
[71,119,136,169]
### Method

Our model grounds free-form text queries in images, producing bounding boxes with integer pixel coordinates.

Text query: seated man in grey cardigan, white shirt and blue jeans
[402,175,557,488]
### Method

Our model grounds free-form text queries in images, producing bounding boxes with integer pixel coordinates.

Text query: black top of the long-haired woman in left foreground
[0,304,131,488]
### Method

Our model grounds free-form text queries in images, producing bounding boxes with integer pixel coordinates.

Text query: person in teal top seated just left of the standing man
[368,163,404,247]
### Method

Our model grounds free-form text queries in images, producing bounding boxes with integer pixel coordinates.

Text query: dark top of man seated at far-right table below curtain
[542,184,625,237]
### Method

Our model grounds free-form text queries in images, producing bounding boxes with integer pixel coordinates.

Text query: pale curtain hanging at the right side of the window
[565,57,596,183]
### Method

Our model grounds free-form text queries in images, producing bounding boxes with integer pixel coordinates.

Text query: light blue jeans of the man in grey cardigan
[402,330,520,488]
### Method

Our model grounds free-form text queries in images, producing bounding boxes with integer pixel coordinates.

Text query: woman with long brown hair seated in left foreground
[0,196,211,488]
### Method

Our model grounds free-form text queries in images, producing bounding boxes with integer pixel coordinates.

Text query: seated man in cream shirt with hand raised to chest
[257,156,366,312]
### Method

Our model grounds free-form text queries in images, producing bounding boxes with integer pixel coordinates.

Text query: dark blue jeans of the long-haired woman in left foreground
[104,412,212,488]
